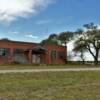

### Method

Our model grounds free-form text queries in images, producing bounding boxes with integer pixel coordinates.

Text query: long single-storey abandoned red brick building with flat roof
[0,40,66,64]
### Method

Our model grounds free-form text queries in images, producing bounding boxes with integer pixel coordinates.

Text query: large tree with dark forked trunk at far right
[74,23,100,64]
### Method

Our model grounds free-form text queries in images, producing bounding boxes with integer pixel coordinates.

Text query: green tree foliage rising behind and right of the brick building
[41,23,100,64]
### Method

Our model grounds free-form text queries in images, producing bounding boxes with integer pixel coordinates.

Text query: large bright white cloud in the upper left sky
[0,0,52,22]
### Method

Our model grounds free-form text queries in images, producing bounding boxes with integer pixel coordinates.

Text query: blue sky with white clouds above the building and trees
[0,0,100,42]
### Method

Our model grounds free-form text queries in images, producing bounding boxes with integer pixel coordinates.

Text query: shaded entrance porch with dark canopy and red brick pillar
[11,46,47,64]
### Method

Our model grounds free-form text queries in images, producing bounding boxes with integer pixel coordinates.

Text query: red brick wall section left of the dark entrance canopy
[0,41,37,63]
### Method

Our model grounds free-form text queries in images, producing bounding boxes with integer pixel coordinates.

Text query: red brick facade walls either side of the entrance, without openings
[0,41,67,64]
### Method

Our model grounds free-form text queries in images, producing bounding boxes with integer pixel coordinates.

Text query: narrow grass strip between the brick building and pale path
[0,64,100,69]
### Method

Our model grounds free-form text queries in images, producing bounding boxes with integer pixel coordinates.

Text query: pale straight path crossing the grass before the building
[0,68,100,74]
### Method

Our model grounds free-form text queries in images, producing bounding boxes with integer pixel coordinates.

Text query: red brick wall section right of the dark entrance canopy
[44,45,67,64]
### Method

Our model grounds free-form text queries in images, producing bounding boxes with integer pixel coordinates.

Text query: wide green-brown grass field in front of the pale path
[0,71,100,100]
